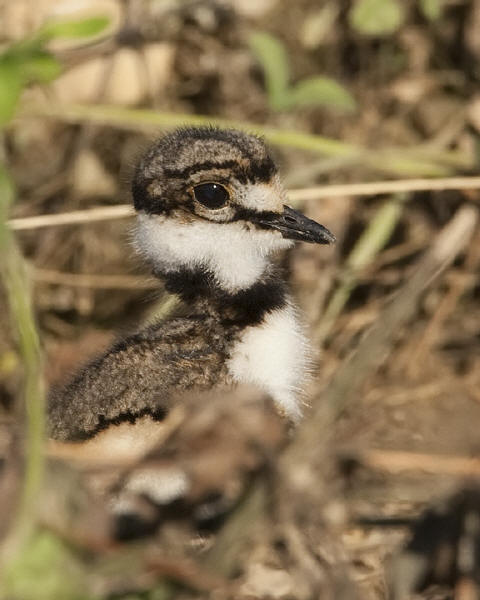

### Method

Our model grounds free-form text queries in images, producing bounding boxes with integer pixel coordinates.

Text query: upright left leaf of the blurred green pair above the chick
[249,32,289,110]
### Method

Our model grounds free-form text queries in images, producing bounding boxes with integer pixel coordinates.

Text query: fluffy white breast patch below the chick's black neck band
[228,304,311,421]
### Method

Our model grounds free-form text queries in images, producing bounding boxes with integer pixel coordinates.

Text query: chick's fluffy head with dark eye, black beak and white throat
[132,127,335,292]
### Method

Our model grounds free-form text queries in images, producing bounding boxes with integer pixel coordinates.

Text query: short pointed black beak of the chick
[259,206,335,244]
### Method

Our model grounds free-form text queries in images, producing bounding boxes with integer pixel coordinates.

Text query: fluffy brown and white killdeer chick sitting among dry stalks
[49,128,335,441]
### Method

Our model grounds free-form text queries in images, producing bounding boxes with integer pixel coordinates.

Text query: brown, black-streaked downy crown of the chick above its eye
[132,127,277,214]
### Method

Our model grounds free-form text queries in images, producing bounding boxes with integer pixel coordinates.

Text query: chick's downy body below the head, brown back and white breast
[49,278,309,441]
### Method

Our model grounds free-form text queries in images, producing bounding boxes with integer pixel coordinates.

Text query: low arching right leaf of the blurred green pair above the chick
[289,77,356,111]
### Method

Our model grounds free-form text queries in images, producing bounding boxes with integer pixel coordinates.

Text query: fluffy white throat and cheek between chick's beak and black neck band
[135,213,293,293]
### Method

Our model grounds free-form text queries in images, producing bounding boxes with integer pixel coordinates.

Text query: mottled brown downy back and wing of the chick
[49,314,231,441]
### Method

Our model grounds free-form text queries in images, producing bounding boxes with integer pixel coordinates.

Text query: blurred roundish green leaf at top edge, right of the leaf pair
[348,0,405,35]
